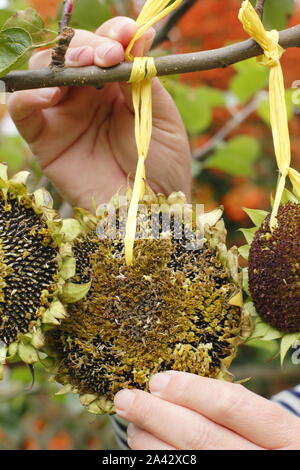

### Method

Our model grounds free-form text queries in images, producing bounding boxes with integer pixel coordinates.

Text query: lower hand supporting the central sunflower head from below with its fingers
[115,371,300,450]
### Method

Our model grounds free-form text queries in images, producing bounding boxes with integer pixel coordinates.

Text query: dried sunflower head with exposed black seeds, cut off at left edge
[0,164,89,375]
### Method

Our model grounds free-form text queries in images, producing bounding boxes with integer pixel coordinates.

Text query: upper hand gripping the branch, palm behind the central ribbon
[8,17,191,209]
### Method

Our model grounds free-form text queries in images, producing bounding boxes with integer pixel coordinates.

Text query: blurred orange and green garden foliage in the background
[0,0,300,450]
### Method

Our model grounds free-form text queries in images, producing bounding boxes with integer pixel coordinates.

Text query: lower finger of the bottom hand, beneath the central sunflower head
[115,389,258,450]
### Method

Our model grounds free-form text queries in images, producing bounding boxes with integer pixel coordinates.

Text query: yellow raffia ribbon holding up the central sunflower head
[124,0,183,266]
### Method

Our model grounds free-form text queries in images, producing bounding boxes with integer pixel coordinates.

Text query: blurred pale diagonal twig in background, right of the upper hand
[193,91,267,161]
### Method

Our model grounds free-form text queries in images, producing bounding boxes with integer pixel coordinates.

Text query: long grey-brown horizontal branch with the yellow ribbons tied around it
[1,25,300,92]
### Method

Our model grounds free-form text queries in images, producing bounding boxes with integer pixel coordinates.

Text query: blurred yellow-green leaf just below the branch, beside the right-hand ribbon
[230,58,269,103]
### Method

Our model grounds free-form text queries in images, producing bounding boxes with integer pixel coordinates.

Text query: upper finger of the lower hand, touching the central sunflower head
[150,371,300,449]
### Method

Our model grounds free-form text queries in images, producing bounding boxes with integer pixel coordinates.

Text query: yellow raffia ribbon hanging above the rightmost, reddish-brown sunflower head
[239,0,300,229]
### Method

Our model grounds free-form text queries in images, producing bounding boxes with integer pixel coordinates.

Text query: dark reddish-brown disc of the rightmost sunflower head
[249,202,300,333]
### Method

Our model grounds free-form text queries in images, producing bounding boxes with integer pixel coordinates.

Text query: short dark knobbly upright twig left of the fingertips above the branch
[50,0,75,70]
